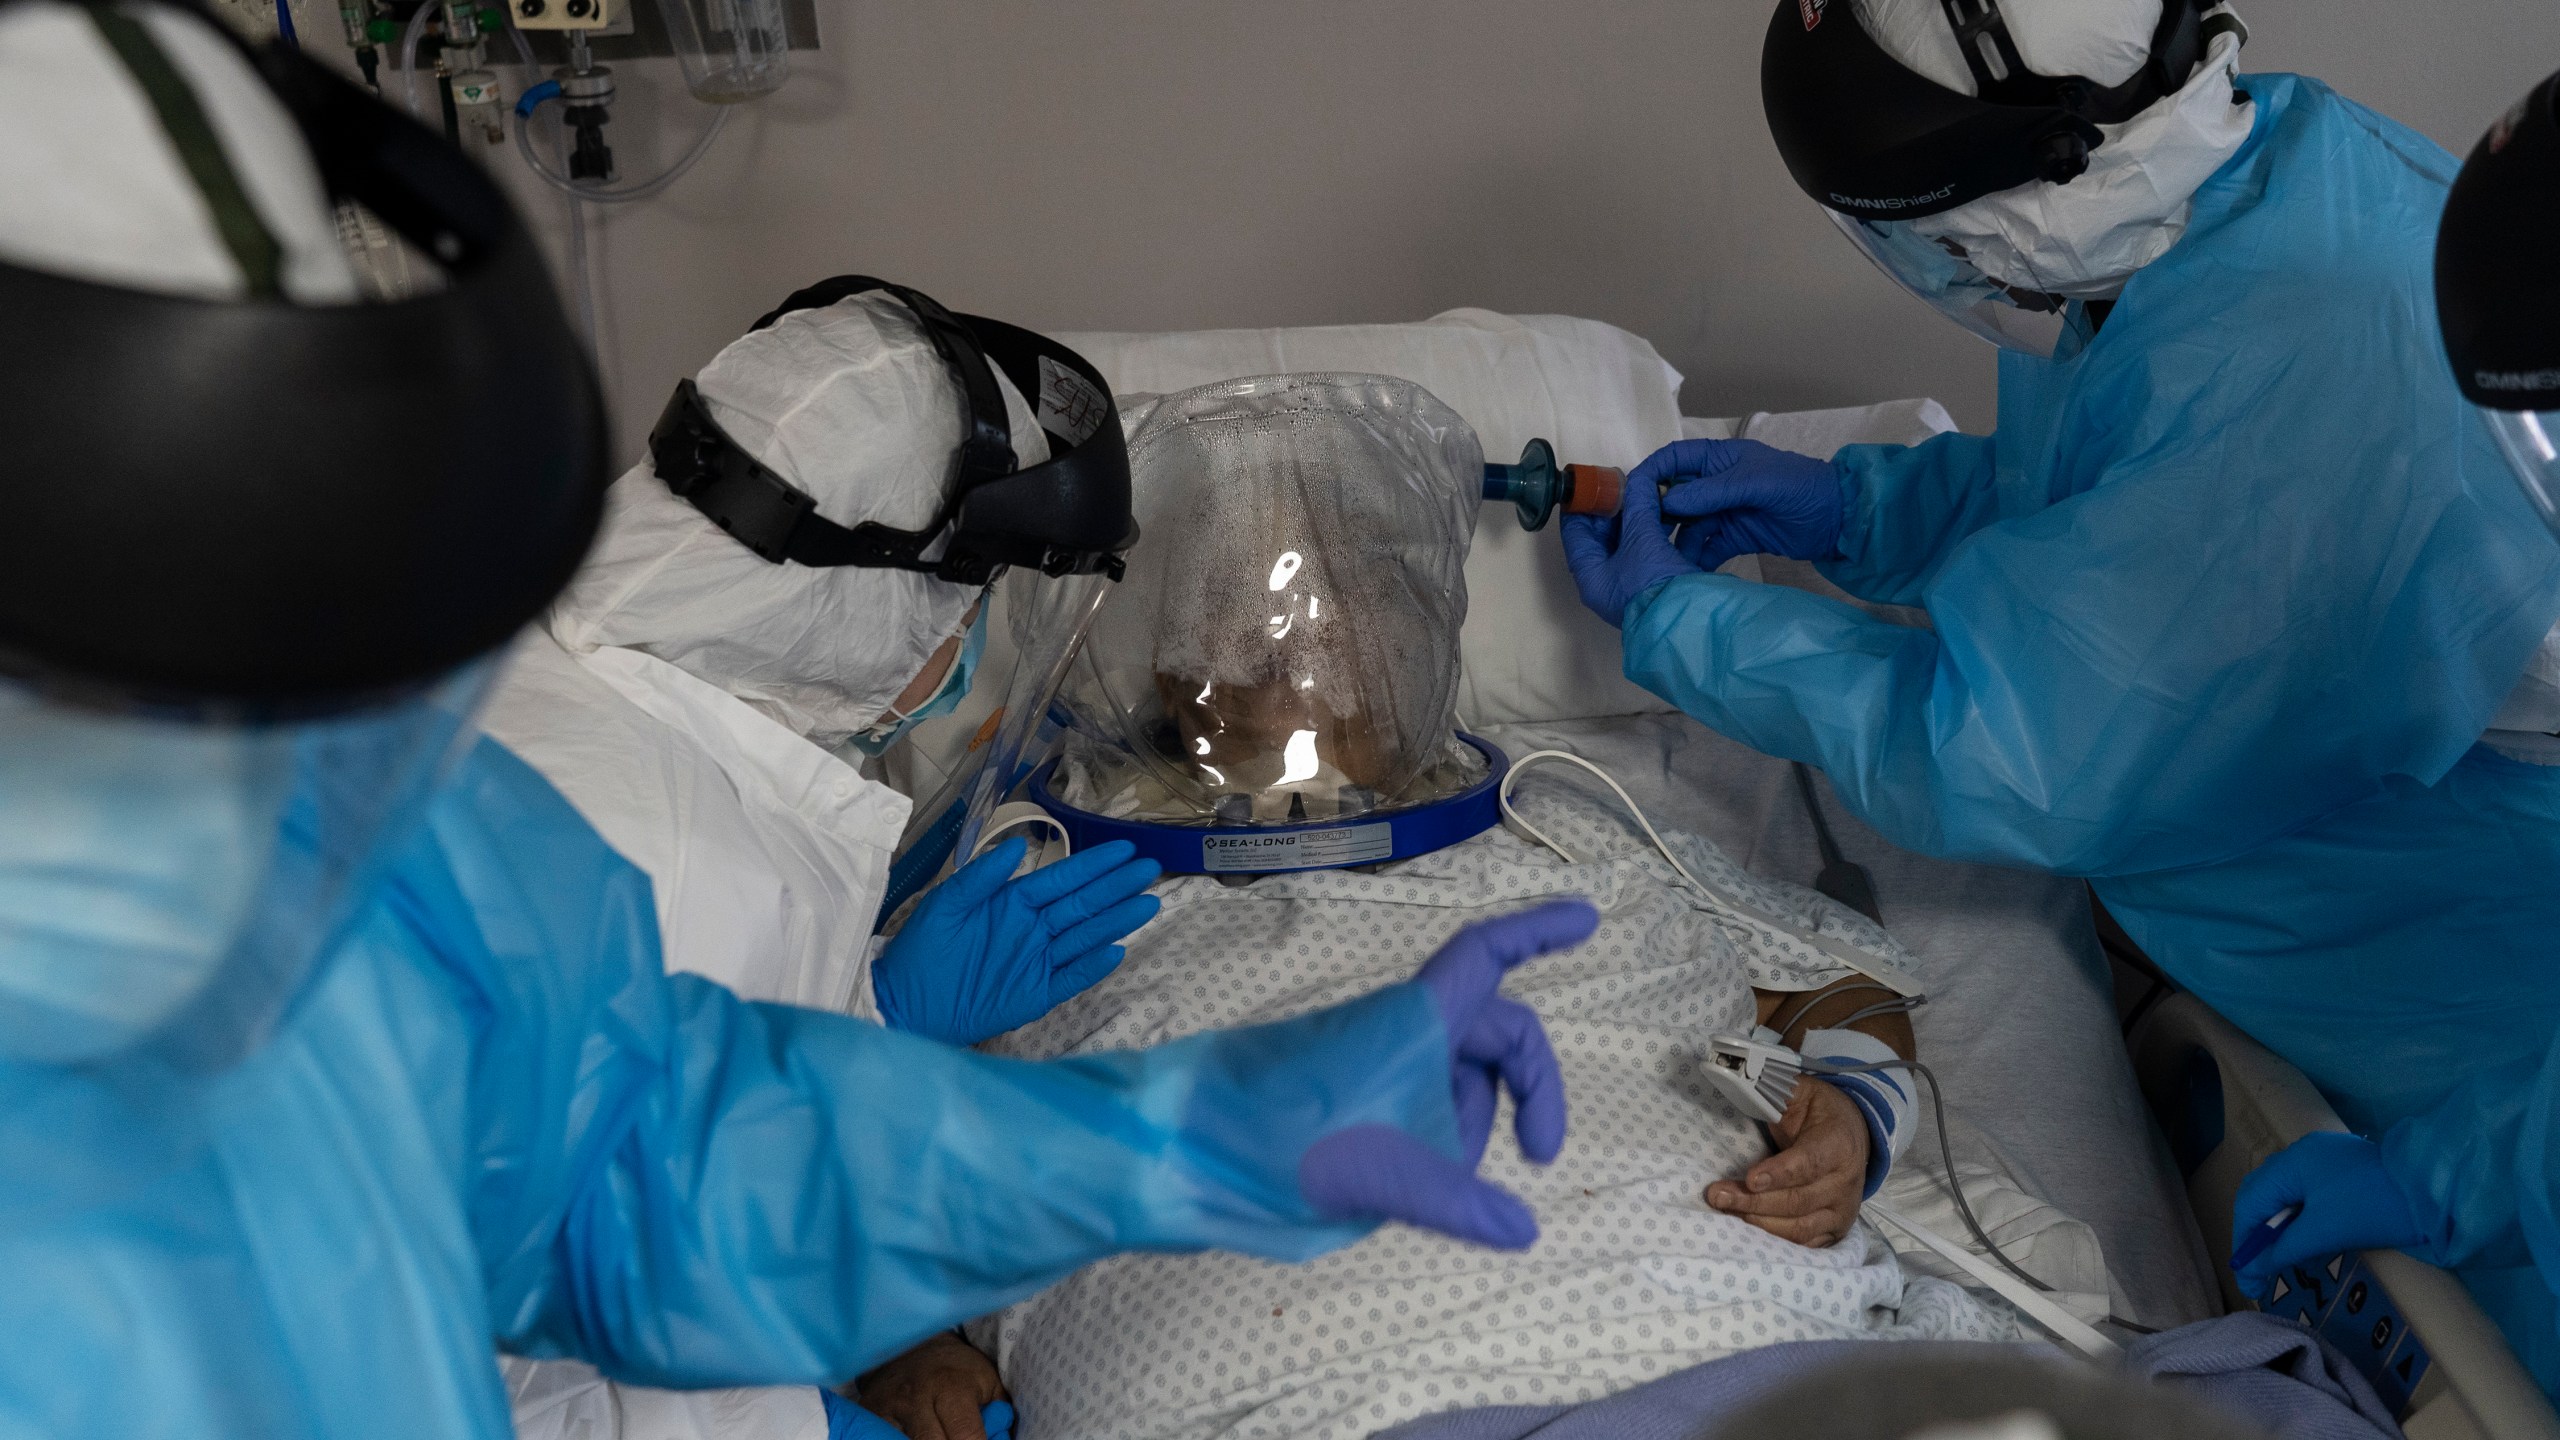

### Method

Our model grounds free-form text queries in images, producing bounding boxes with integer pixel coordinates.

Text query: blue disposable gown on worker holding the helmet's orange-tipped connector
[1626,74,2560,1383]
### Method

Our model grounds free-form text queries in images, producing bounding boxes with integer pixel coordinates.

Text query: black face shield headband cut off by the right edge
[2435,74,2560,410]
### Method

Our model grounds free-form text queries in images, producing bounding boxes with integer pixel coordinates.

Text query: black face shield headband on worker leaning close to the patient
[648,274,1137,584]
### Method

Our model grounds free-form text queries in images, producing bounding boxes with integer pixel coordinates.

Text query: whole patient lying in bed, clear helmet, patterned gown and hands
[860,377,2017,1440]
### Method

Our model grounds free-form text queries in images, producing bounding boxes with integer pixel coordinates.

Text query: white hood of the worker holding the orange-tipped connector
[1859,0,2255,300]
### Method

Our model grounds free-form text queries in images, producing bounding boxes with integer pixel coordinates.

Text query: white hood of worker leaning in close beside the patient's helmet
[550,295,1050,748]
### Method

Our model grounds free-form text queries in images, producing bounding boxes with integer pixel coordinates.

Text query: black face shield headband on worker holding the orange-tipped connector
[1761,0,2237,220]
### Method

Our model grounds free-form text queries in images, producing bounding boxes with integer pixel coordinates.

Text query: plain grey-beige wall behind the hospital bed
[445,0,2560,454]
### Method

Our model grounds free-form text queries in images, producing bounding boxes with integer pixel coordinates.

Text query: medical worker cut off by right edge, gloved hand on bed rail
[2232,74,2560,1396]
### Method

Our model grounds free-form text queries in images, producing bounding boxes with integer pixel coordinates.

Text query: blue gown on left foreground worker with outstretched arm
[0,740,1457,1440]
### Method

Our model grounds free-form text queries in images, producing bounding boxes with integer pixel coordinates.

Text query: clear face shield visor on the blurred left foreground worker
[0,659,497,1071]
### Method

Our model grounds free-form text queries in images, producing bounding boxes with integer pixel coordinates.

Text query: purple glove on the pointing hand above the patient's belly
[1298,899,1600,1250]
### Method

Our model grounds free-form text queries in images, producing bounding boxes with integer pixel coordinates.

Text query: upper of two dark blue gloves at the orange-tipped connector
[1626,441,1846,569]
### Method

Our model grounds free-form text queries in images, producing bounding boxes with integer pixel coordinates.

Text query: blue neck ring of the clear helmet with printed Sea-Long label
[1032,730,1510,874]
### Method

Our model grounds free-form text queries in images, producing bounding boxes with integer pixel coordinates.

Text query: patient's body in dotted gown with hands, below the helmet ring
[863,769,2017,1440]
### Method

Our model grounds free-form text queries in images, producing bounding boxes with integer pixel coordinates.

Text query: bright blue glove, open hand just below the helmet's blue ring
[870,835,1162,1045]
